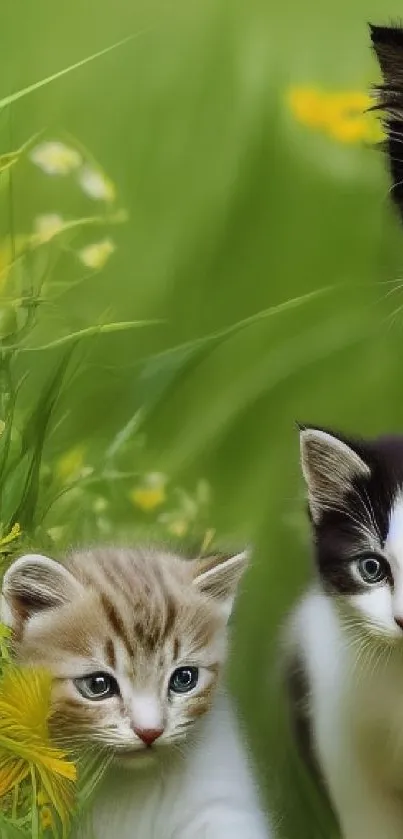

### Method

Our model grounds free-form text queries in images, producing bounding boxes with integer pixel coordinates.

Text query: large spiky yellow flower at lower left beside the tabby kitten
[0,665,77,832]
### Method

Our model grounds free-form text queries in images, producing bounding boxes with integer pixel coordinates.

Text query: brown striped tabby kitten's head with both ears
[3,550,246,760]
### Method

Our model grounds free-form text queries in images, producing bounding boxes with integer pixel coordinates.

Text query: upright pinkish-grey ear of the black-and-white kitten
[300,427,371,524]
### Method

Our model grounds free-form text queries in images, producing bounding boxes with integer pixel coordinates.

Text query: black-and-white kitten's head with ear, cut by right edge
[301,428,403,642]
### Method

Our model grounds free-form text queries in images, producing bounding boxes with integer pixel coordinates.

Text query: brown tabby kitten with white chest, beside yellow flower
[2,549,269,839]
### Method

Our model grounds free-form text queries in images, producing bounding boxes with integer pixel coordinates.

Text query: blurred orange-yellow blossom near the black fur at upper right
[287,87,383,144]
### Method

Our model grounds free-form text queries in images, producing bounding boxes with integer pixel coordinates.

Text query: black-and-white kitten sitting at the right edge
[288,428,403,839]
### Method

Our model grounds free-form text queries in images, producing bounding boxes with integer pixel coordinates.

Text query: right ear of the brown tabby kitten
[193,551,249,619]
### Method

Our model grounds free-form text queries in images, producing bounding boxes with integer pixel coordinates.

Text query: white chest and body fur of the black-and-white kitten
[291,588,403,839]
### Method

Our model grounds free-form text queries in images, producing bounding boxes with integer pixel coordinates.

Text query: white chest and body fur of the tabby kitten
[77,694,271,839]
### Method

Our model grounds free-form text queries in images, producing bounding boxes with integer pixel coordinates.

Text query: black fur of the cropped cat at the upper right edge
[370,26,403,219]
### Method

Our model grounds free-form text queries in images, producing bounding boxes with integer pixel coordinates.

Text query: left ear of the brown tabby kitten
[1,554,80,626]
